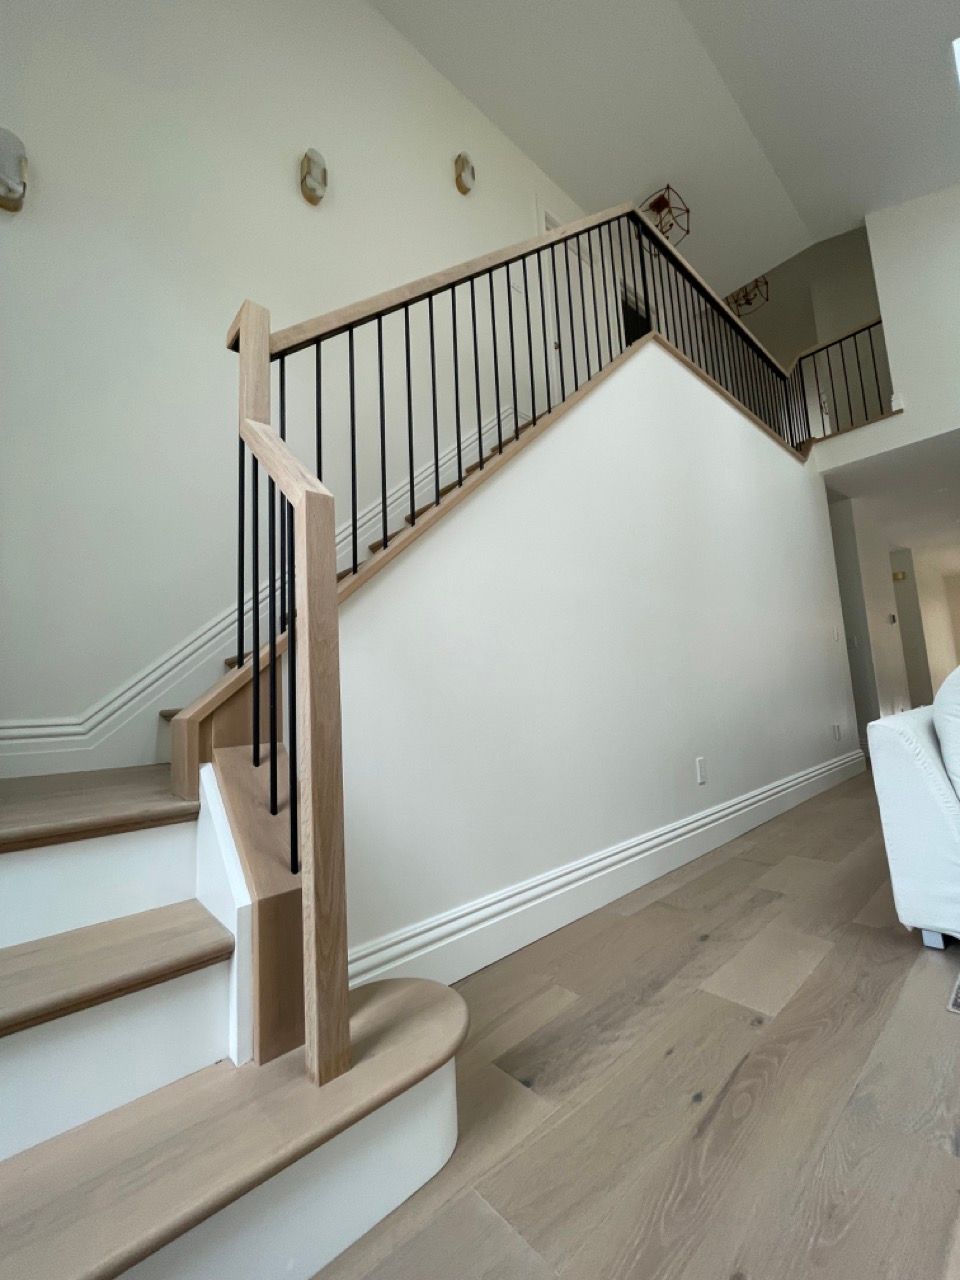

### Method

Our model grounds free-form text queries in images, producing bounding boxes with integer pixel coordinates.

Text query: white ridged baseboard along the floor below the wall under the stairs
[349,750,865,983]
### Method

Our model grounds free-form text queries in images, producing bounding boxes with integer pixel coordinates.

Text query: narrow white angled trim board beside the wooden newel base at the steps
[196,764,253,1066]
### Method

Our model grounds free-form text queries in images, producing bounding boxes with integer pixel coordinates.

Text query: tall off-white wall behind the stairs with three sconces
[0,0,579,742]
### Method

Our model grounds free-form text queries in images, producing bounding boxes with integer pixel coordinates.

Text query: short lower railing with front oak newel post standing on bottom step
[236,302,349,1084]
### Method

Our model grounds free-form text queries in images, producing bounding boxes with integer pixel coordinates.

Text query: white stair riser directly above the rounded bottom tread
[0,962,230,1160]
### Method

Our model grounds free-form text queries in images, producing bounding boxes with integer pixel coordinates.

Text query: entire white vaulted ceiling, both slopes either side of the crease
[374,0,960,277]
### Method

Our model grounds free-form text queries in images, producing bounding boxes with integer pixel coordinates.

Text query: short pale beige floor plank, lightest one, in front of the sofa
[701,919,831,1018]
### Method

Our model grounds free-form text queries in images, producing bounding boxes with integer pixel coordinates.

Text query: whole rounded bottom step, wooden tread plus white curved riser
[0,979,467,1280]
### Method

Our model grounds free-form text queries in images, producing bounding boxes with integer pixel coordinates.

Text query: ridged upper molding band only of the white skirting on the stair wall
[0,403,530,776]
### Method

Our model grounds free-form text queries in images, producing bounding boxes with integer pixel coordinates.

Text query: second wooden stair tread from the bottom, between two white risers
[0,900,233,1036]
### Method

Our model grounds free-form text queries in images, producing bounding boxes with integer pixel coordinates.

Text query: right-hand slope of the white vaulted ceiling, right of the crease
[678,0,960,239]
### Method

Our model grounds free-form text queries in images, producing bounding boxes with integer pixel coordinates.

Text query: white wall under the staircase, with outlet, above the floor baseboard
[340,344,856,951]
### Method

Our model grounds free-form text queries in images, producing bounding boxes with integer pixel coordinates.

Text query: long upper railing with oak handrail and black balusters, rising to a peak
[230,205,809,599]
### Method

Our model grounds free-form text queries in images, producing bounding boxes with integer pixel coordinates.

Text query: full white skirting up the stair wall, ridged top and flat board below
[0,403,530,777]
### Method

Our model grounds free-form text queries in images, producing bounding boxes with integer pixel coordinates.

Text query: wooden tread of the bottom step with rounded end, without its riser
[0,978,467,1280]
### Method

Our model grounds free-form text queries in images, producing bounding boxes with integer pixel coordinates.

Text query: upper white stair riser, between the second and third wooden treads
[0,822,197,947]
